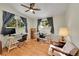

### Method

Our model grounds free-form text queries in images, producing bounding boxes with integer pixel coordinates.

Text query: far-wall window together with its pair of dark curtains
[37,17,54,33]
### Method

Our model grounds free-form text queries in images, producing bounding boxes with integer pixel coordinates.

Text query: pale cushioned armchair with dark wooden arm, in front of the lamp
[48,42,78,56]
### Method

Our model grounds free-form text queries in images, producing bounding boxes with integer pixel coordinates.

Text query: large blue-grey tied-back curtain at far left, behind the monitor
[1,11,15,34]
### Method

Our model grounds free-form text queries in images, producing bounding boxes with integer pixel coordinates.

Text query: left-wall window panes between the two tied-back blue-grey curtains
[6,17,25,34]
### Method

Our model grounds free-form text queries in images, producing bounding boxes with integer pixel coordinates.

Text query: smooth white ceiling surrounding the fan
[10,3,68,18]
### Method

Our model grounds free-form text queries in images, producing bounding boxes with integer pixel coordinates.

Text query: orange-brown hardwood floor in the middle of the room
[2,39,49,56]
